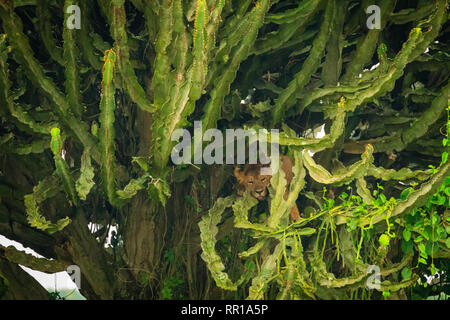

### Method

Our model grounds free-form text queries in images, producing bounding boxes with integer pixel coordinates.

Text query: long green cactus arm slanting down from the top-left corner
[0,7,100,162]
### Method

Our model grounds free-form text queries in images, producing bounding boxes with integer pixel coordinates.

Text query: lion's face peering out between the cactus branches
[234,164,272,200]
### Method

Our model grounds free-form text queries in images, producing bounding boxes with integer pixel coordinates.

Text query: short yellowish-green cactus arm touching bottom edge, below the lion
[247,243,283,300]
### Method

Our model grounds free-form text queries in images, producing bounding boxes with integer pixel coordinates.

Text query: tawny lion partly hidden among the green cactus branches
[234,155,300,221]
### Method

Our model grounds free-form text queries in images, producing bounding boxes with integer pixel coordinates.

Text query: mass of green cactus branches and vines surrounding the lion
[0,0,450,299]
